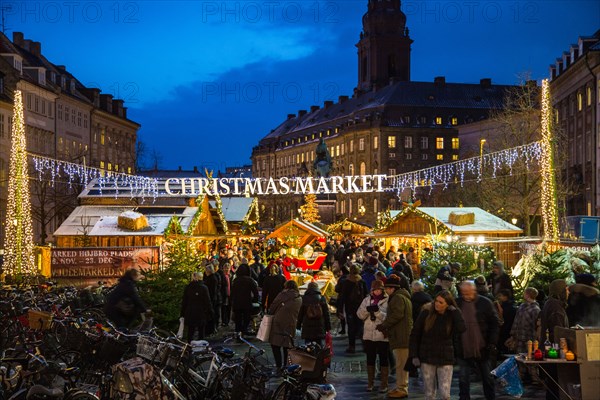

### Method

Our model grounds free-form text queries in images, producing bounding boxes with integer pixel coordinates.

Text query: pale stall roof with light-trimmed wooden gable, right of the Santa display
[376,207,523,237]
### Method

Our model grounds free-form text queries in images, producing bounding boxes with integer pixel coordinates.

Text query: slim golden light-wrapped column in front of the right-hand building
[541,79,559,242]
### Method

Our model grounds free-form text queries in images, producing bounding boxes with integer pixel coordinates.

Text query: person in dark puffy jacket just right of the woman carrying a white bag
[296,282,331,346]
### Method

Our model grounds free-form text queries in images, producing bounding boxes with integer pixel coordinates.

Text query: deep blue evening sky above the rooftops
[5,0,600,170]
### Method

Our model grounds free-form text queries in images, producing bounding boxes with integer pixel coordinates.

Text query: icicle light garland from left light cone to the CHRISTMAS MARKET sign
[29,153,158,203]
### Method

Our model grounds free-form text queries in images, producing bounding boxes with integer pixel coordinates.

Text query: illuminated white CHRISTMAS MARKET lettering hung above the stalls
[164,175,387,196]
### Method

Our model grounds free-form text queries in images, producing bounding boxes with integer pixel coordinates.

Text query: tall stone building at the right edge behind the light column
[550,30,600,216]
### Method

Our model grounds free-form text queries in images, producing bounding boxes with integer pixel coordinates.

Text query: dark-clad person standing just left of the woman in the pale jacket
[340,264,368,354]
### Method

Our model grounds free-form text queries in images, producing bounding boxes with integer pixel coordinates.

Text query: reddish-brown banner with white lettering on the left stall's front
[50,247,159,282]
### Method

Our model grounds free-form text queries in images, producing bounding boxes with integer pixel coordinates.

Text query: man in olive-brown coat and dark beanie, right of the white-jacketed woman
[376,274,413,399]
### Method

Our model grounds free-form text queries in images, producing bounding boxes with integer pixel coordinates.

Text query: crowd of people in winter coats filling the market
[108,241,600,400]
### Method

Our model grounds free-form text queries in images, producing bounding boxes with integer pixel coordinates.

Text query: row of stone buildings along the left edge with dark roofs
[0,32,140,247]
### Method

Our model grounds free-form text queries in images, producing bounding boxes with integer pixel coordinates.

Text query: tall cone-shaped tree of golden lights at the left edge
[4,90,36,276]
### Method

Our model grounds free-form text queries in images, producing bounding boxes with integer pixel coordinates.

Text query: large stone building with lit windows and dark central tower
[252,0,509,225]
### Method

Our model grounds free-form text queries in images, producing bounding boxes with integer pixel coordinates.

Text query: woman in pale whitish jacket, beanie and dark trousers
[356,280,390,393]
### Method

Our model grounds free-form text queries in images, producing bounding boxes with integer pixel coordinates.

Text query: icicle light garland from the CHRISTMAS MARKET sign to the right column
[387,141,543,198]
